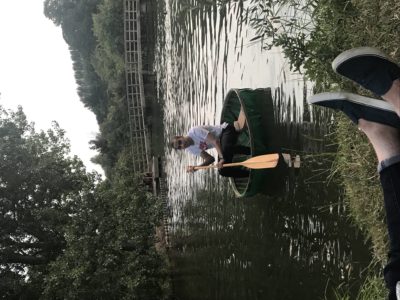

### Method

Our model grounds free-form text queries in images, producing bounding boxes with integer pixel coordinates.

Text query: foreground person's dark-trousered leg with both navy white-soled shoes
[309,47,400,300]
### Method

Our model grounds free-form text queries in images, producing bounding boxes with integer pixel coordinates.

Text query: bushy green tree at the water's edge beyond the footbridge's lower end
[45,156,166,299]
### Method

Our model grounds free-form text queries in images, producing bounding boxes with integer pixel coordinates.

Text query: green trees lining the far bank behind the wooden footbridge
[0,0,169,299]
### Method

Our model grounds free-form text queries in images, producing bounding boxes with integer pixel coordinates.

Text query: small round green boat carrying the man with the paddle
[221,88,284,197]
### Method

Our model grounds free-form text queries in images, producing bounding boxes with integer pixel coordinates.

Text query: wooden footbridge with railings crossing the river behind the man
[122,0,170,249]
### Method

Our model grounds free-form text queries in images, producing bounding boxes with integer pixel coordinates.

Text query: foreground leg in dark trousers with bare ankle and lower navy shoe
[309,93,400,300]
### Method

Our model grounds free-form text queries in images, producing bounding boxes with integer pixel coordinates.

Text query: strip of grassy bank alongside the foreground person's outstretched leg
[332,113,387,300]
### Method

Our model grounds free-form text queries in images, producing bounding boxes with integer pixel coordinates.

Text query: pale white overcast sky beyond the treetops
[0,0,102,173]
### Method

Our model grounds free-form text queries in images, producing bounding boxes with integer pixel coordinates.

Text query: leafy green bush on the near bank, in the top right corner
[246,0,400,91]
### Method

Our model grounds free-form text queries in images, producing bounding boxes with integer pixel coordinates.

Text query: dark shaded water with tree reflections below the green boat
[173,120,369,299]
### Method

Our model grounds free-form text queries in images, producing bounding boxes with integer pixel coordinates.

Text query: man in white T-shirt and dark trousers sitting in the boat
[170,110,250,177]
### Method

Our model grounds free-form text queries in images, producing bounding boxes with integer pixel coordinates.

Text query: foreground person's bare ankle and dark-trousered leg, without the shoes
[358,119,400,300]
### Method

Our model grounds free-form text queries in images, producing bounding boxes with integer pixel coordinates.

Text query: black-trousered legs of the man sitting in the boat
[218,125,249,178]
